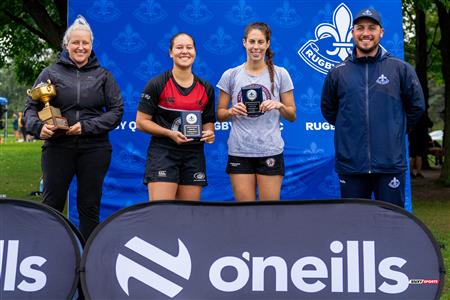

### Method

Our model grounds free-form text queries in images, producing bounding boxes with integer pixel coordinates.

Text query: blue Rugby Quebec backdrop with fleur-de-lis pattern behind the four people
[68,0,411,223]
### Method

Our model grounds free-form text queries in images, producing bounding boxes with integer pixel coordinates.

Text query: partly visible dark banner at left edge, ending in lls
[0,199,81,299]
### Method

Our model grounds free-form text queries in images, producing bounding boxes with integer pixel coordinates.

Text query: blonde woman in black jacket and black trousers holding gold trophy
[25,16,123,239]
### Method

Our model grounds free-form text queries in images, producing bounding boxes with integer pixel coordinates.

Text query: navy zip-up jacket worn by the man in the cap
[321,47,425,174]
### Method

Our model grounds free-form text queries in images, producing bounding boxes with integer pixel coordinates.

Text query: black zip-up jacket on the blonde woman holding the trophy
[24,50,123,145]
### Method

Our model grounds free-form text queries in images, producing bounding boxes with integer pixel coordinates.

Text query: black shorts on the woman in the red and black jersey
[144,143,208,186]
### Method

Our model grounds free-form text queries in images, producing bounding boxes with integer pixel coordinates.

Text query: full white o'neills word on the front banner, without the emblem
[209,241,409,294]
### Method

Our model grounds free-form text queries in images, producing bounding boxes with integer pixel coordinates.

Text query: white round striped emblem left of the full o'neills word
[116,236,192,298]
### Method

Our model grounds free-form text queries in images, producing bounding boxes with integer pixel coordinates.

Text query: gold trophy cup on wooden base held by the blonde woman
[27,79,69,131]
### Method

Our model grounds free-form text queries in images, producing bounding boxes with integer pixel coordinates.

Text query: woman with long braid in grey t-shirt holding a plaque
[217,22,296,201]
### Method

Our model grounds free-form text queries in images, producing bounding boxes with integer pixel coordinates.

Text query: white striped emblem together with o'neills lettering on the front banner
[116,237,439,298]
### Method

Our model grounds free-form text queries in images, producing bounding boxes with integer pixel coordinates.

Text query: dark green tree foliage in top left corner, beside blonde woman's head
[0,0,67,85]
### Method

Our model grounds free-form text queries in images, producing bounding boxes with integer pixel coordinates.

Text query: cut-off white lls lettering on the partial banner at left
[0,240,47,292]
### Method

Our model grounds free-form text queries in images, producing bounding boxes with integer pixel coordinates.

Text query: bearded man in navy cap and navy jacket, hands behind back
[321,8,425,207]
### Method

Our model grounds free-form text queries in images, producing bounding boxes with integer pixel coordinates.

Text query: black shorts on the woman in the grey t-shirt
[226,153,284,176]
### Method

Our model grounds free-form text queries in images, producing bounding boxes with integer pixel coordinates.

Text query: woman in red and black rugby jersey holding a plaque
[136,33,216,201]
